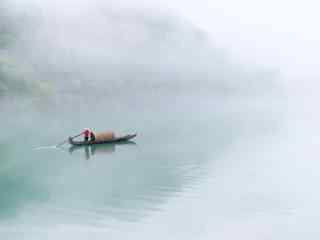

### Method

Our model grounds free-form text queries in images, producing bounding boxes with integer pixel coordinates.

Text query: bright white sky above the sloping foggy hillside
[164,0,320,76]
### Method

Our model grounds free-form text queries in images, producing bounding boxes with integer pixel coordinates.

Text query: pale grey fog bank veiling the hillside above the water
[0,1,279,98]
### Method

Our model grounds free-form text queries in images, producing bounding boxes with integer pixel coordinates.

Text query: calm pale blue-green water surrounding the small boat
[0,88,318,239]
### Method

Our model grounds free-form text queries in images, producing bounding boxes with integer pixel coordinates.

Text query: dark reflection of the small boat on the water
[69,141,136,160]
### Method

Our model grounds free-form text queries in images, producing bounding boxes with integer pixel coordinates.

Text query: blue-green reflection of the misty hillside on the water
[0,93,278,239]
